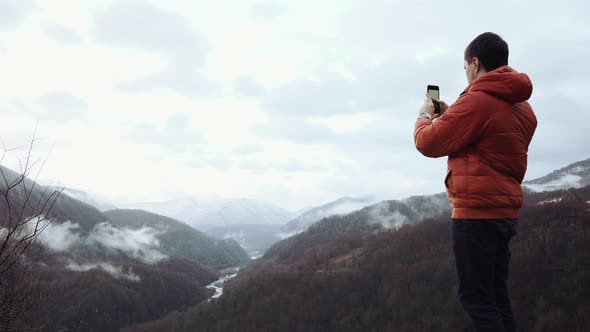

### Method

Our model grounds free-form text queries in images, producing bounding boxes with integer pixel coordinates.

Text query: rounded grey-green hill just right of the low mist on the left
[104,210,249,268]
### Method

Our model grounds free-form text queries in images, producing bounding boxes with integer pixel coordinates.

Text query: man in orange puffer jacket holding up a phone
[414,32,537,331]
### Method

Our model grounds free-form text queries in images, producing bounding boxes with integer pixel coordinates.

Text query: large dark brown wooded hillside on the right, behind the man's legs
[124,186,590,332]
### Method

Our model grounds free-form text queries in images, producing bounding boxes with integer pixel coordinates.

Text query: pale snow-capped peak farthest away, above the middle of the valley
[188,198,295,229]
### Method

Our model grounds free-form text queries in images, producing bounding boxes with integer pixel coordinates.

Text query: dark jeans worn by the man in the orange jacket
[453,219,517,332]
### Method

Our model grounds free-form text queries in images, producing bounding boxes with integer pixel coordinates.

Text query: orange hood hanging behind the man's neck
[465,66,533,104]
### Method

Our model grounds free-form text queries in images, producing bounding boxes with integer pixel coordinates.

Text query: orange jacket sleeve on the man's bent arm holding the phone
[414,93,491,158]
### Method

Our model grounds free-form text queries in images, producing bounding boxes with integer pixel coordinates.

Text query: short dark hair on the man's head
[465,32,508,71]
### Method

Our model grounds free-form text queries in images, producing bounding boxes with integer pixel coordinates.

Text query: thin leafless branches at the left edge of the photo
[0,136,63,331]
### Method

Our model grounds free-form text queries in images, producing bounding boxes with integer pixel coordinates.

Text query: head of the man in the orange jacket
[464,32,508,83]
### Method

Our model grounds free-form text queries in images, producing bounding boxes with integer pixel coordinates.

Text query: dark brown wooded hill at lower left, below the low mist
[19,253,218,332]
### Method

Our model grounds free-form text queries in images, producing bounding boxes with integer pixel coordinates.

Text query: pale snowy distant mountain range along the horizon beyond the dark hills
[40,159,590,264]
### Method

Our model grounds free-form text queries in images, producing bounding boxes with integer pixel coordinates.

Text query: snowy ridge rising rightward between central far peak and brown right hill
[280,196,377,238]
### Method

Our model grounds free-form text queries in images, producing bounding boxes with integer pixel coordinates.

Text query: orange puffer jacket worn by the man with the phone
[414,66,537,219]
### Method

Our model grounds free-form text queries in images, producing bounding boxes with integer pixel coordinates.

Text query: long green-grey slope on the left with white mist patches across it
[0,167,249,269]
